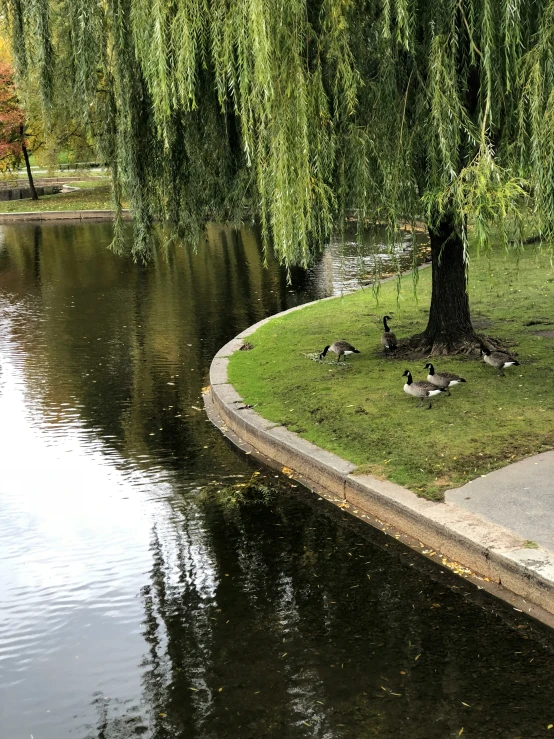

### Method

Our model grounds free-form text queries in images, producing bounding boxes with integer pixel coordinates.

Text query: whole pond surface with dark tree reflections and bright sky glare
[0,224,554,739]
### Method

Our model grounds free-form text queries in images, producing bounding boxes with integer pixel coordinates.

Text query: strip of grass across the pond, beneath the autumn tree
[0,180,117,213]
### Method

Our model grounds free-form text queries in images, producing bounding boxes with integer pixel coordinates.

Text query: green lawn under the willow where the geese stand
[229,247,554,499]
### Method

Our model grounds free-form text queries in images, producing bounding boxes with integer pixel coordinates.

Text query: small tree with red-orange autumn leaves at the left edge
[0,60,38,200]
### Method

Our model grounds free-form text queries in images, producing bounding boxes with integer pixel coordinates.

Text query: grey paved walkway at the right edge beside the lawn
[446,452,554,552]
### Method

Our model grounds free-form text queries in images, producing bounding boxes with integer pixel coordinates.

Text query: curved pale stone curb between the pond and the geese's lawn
[206,284,554,620]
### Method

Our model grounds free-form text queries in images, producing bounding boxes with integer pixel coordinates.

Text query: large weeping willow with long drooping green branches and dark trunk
[0,0,554,353]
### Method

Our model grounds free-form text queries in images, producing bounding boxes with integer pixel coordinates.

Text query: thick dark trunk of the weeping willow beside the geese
[410,216,480,355]
